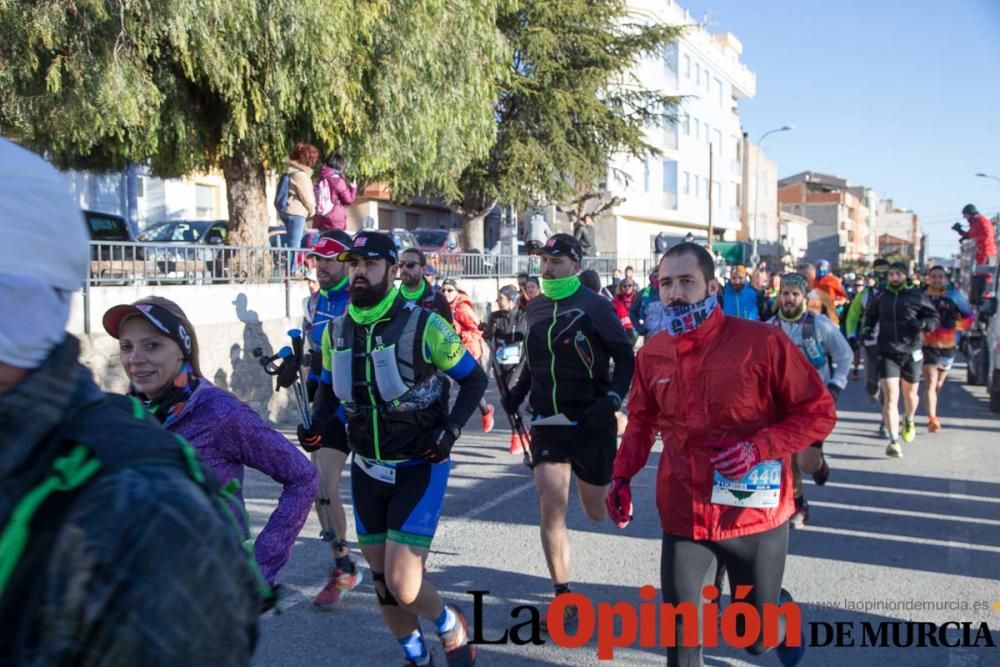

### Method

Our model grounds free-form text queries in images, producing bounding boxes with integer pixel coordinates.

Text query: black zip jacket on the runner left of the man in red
[512,286,635,420]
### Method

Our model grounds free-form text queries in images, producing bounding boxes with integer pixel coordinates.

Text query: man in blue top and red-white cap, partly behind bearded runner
[298,230,362,608]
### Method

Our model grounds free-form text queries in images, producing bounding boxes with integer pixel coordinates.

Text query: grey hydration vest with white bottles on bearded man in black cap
[328,301,443,415]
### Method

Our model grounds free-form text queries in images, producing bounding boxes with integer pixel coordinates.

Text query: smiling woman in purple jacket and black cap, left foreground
[104,296,319,584]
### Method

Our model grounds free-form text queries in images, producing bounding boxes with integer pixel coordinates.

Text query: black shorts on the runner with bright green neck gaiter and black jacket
[531,420,618,486]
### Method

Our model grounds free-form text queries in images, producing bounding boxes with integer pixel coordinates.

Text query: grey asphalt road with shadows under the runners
[246,366,1000,667]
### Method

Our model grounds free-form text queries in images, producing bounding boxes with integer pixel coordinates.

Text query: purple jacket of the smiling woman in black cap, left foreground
[167,378,319,584]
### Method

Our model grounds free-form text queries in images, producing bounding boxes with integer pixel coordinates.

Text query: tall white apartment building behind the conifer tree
[598,0,752,257]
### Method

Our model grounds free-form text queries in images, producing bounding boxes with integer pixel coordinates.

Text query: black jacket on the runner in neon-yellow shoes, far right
[864,287,940,354]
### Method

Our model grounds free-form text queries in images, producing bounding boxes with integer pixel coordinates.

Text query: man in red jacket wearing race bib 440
[607,243,836,665]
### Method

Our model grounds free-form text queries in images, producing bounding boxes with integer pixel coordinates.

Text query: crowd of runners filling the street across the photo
[0,141,996,665]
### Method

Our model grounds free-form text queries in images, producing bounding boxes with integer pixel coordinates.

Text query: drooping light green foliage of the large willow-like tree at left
[0,0,509,232]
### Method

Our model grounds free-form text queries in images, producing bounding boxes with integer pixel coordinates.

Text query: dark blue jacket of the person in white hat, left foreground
[0,337,260,667]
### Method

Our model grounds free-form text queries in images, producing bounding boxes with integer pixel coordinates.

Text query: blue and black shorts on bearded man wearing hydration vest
[351,454,451,549]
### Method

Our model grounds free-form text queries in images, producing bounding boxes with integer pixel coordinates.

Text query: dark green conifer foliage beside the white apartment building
[456,0,682,216]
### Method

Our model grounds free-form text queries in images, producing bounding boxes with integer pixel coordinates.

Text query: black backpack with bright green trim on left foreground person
[0,394,273,662]
